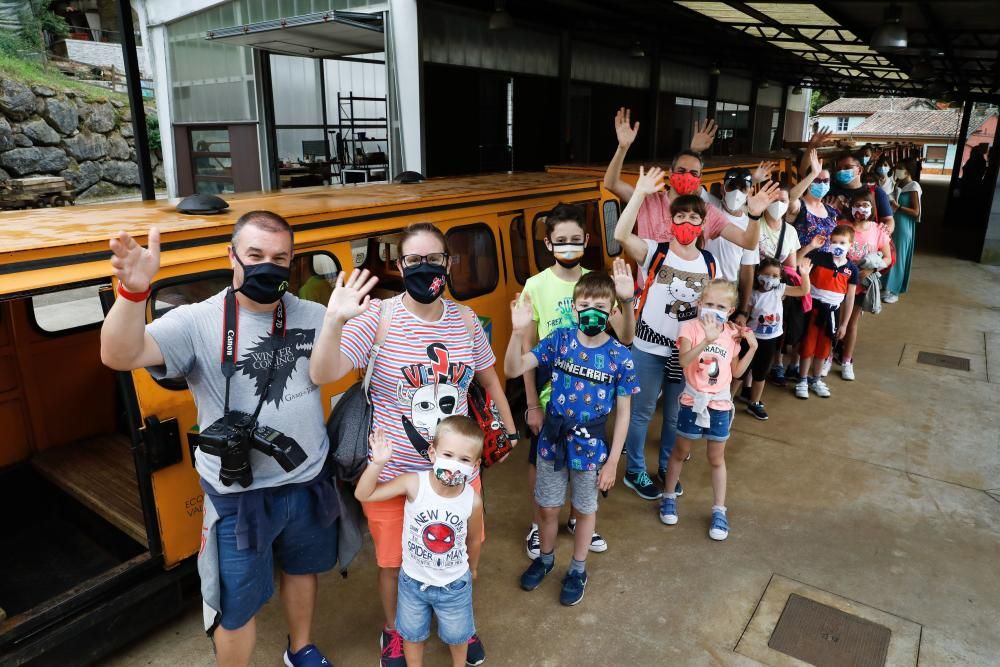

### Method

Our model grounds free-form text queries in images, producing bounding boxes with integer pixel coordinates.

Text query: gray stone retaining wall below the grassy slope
[0,76,165,199]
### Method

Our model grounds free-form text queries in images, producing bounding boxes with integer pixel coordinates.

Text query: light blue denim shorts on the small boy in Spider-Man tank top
[396,570,476,644]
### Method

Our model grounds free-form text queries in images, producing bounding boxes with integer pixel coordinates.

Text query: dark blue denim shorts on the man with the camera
[215,486,339,630]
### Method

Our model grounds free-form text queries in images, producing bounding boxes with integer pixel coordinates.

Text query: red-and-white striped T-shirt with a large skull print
[341,299,496,482]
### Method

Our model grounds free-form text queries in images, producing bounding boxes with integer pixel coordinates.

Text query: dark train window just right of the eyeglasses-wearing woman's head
[447,222,500,301]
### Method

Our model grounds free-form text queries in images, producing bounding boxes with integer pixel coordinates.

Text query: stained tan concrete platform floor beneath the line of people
[107,223,1000,667]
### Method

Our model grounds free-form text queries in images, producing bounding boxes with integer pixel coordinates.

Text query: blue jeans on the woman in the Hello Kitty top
[625,347,684,474]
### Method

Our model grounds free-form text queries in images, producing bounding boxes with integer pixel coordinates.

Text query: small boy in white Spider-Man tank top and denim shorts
[354,415,483,667]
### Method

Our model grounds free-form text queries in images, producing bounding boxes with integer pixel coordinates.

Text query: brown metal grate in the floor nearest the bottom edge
[767,593,892,667]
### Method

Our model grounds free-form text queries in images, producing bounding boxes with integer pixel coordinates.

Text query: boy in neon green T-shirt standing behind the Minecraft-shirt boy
[523,204,635,560]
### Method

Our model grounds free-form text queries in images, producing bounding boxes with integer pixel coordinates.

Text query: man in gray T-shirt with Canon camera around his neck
[101,211,375,667]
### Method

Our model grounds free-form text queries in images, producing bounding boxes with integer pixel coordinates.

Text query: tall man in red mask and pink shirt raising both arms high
[604,107,780,251]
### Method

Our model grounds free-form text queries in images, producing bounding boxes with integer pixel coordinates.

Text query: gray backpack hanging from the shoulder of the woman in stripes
[326,299,394,480]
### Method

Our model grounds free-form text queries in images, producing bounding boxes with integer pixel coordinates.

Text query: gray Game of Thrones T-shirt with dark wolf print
[146,290,329,493]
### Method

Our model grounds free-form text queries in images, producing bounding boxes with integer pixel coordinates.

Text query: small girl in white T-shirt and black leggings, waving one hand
[747,257,812,421]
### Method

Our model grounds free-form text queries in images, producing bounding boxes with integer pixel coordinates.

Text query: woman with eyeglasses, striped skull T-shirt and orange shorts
[310,223,516,666]
